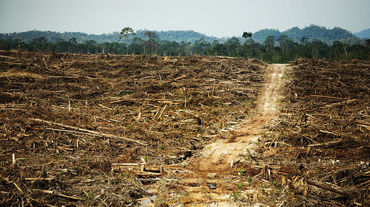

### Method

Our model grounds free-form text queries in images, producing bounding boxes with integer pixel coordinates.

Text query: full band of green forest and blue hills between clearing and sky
[0,25,370,63]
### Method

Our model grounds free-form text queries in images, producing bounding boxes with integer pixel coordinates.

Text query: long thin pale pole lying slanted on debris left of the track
[30,118,147,146]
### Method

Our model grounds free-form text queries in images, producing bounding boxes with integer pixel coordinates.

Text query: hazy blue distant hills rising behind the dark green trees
[0,25,362,44]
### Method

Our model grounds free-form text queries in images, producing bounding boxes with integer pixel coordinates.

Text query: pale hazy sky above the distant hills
[0,0,370,37]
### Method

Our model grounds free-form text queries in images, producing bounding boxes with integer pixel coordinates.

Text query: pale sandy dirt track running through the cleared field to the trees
[143,64,286,206]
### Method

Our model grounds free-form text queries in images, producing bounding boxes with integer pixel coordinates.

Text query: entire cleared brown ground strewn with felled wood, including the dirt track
[0,51,370,206]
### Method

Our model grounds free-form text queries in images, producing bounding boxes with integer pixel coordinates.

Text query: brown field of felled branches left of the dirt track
[0,51,265,206]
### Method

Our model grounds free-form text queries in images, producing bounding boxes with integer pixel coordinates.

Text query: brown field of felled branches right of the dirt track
[268,59,370,206]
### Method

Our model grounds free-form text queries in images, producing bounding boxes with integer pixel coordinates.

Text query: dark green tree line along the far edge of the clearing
[0,28,370,63]
